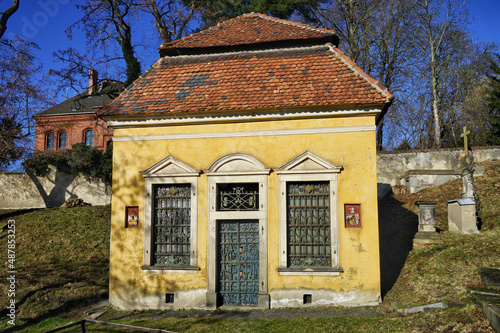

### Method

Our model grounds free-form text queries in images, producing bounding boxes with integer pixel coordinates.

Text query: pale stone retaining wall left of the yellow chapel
[0,167,111,209]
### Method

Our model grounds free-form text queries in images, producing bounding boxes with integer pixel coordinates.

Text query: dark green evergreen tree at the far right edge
[487,54,500,145]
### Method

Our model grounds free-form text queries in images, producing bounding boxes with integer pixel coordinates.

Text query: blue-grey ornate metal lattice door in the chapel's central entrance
[218,220,259,306]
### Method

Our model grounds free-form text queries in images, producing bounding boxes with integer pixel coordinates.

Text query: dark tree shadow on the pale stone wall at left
[26,168,77,208]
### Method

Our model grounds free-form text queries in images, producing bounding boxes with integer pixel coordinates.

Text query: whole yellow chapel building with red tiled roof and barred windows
[100,13,393,309]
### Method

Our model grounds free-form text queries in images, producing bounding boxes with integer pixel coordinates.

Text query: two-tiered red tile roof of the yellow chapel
[100,14,393,116]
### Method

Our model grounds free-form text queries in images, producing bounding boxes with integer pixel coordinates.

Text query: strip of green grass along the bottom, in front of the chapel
[23,307,493,333]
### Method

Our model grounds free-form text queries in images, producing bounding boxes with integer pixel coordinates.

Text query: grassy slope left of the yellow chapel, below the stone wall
[0,207,110,329]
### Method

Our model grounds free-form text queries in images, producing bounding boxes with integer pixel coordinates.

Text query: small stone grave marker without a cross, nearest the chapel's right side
[413,201,443,248]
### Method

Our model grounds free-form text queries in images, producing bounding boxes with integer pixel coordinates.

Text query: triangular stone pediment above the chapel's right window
[275,150,342,174]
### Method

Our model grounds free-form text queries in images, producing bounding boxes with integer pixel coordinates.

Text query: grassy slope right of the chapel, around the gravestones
[384,161,500,308]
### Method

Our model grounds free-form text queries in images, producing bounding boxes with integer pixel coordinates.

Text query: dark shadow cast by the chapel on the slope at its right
[378,194,418,297]
